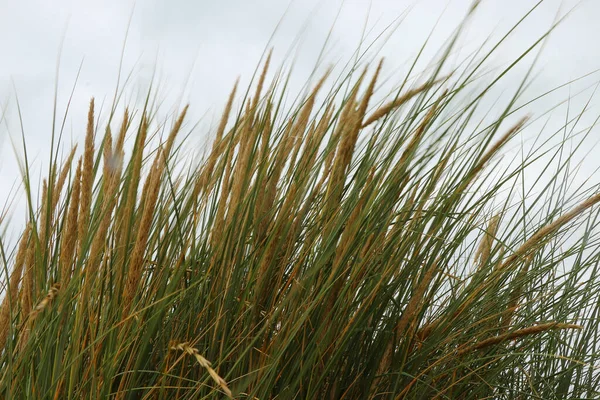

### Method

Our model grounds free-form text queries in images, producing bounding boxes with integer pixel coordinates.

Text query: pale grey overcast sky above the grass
[0,0,600,231]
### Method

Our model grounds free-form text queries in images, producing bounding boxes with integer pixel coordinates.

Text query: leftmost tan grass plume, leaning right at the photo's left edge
[0,223,31,349]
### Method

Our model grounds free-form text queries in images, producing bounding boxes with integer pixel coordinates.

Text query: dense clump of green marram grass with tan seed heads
[0,10,600,400]
